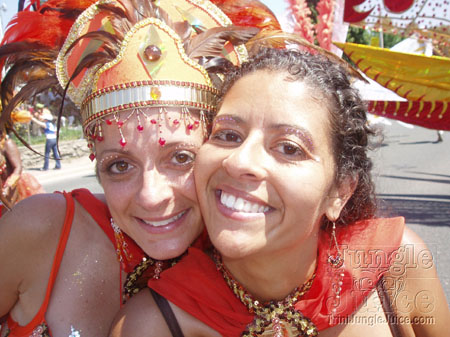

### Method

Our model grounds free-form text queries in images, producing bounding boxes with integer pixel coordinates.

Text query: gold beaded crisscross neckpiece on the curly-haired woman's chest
[213,250,318,337]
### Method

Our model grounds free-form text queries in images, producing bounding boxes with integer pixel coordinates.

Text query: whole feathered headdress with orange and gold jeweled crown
[0,0,279,155]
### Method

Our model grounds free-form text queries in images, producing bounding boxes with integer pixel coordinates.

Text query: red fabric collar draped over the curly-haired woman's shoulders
[148,217,404,337]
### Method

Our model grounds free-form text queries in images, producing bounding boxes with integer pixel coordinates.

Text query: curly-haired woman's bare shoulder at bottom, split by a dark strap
[110,288,220,337]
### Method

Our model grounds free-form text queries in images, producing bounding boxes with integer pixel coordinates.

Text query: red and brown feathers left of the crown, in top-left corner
[0,0,95,145]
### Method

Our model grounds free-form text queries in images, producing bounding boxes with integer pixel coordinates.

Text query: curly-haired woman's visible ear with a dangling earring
[325,176,358,221]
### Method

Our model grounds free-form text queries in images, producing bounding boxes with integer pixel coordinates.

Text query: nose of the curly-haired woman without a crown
[223,135,267,180]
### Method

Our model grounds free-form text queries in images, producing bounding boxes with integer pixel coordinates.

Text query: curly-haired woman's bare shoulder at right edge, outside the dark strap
[385,227,450,336]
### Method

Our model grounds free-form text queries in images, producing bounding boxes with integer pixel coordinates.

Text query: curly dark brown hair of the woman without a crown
[219,48,378,226]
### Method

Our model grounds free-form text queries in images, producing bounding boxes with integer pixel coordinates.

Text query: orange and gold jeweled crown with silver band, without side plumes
[56,0,250,134]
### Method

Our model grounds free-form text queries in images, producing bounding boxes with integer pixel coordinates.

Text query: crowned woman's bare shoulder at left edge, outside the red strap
[0,194,66,316]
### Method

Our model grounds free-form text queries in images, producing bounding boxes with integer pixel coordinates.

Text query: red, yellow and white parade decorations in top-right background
[286,0,450,131]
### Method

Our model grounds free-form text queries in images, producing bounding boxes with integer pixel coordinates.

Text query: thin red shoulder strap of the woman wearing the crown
[7,192,75,337]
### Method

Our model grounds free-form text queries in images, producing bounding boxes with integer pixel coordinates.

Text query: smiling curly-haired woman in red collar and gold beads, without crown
[113,48,450,337]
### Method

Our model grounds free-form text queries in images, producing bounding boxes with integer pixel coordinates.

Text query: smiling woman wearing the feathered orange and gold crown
[0,0,270,337]
